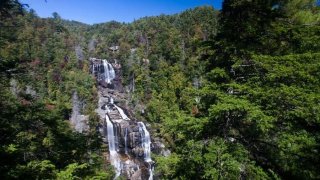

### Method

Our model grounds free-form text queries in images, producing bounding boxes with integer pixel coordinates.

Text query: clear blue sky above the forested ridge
[20,0,222,24]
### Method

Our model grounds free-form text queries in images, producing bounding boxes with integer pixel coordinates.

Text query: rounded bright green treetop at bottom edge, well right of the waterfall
[204,139,271,179]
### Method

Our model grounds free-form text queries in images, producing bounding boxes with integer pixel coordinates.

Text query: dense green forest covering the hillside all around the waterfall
[0,0,320,179]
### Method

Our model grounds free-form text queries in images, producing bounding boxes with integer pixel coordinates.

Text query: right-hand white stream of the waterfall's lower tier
[138,122,153,180]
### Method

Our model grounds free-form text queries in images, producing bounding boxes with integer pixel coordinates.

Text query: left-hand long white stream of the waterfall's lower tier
[106,115,121,179]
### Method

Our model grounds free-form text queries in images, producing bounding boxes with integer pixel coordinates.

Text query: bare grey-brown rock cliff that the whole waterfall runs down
[90,58,170,180]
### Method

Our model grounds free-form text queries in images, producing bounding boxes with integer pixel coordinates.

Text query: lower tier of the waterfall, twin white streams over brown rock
[101,98,153,180]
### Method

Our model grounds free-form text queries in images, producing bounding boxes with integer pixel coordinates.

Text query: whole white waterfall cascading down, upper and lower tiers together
[91,58,159,180]
